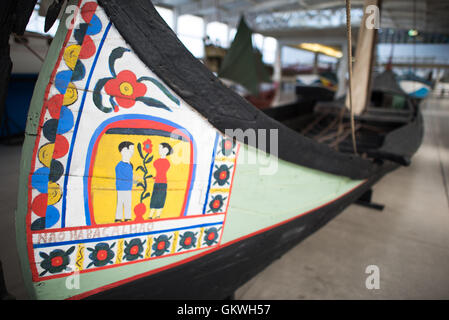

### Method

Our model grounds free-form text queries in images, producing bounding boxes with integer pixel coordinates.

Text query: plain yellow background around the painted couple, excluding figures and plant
[91,134,190,224]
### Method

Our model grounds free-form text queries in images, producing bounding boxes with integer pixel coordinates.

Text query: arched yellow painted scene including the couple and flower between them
[89,128,193,224]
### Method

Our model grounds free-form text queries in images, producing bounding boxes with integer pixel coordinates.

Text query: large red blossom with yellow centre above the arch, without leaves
[104,70,147,108]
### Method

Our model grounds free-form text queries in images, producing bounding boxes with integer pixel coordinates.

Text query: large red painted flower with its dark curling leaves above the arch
[92,47,180,113]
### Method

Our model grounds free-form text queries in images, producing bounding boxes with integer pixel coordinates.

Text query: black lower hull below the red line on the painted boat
[86,162,399,300]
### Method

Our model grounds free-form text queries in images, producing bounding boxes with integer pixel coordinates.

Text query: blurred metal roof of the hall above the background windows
[153,0,449,38]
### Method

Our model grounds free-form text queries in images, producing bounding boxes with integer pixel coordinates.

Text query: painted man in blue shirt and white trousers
[115,141,134,222]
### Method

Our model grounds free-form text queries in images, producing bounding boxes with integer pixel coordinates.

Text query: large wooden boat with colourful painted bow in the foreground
[11,0,422,299]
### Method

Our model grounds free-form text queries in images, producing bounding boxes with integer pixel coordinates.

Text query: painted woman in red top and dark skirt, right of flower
[150,142,173,219]
